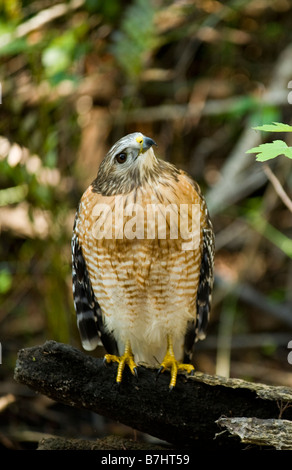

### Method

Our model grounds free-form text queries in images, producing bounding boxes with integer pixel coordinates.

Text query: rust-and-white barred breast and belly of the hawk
[74,168,214,364]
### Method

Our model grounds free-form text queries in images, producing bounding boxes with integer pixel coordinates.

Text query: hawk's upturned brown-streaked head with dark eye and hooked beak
[93,132,158,196]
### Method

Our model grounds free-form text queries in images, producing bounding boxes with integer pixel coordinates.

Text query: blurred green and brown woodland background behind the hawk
[0,0,292,448]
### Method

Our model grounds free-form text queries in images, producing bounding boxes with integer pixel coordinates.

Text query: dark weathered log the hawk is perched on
[15,341,292,449]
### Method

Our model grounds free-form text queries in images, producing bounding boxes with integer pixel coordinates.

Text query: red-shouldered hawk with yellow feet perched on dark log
[72,132,214,389]
